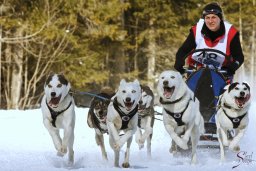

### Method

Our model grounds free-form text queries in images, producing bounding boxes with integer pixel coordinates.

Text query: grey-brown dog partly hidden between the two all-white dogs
[135,86,154,157]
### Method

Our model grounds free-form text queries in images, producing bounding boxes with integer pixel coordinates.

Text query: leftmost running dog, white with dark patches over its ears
[41,74,75,164]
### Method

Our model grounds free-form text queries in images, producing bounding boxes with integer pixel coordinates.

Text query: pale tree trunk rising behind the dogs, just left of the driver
[147,19,156,89]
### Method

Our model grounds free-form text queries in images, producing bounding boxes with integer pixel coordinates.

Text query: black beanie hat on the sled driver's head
[202,2,223,20]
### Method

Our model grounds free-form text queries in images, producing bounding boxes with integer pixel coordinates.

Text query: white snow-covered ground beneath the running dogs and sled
[0,102,256,171]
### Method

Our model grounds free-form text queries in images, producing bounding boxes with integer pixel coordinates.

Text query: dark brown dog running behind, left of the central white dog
[87,87,114,160]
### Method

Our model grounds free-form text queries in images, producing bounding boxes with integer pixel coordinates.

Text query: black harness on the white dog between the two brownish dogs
[113,98,138,130]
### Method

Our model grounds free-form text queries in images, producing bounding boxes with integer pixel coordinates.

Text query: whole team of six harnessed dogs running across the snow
[41,70,251,168]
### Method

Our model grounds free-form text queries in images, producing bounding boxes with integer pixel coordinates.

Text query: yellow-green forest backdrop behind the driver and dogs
[0,0,256,109]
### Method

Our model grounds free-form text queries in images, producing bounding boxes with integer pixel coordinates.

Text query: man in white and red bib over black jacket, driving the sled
[174,2,244,78]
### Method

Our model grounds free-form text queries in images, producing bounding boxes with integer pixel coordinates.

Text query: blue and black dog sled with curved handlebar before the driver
[186,49,231,148]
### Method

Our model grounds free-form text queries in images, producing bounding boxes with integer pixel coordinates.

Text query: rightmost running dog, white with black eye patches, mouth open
[215,82,251,161]
